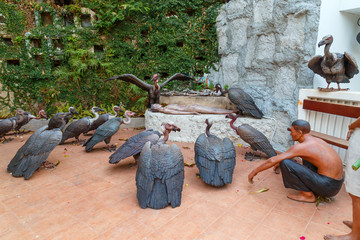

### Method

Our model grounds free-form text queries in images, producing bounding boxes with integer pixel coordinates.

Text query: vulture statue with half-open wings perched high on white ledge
[308,35,359,91]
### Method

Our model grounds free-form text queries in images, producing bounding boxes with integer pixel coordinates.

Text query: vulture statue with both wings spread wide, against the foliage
[104,73,193,107]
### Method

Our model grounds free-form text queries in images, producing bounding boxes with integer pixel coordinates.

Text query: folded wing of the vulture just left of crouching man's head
[238,124,277,157]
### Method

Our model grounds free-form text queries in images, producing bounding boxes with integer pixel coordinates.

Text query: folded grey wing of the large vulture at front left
[7,126,62,180]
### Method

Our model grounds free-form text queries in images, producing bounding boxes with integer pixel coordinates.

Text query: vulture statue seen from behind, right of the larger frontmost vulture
[194,119,236,187]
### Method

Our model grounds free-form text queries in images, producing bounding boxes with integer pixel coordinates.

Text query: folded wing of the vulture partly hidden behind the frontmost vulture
[109,129,161,164]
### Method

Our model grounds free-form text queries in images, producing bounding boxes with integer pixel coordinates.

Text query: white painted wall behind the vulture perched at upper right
[314,0,360,91]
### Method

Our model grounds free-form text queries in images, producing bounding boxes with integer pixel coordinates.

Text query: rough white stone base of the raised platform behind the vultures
[145,110,276,146]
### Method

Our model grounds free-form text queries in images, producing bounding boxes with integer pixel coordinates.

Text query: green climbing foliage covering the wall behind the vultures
[0,0,222,116]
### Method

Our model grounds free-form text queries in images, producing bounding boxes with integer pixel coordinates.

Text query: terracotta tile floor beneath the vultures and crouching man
[0,129,351,240]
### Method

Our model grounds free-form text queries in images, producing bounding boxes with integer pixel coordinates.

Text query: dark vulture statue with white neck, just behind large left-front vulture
[60,107,103,144]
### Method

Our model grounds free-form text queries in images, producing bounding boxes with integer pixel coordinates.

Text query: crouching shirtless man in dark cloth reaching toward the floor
[248,120,344,202]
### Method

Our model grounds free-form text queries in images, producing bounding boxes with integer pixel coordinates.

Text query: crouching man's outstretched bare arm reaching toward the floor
[248,144,300,183]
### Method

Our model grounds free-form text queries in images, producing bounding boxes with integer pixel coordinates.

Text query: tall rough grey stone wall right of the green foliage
[209,0,321,150]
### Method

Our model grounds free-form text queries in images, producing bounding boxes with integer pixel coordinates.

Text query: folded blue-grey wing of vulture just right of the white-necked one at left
[83,118,121,151]
